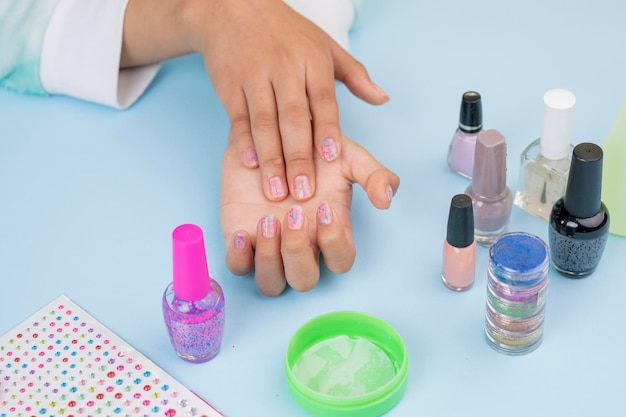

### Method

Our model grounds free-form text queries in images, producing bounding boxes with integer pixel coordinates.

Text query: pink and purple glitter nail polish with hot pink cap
[162,224,225,363]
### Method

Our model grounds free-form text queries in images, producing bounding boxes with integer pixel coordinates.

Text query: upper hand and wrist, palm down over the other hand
[121,0,388,202]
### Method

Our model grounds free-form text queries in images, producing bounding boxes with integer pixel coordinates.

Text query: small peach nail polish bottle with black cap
[441,194,476,292]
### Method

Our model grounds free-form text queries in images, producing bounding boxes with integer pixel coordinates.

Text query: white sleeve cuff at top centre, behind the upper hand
[285,0,356,50]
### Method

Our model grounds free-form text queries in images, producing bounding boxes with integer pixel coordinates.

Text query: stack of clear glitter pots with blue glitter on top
[485,232,550,355]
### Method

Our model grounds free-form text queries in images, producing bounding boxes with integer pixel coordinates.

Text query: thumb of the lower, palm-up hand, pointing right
[344,137,400,209]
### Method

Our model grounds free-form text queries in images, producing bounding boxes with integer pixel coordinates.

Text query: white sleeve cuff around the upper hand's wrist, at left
[40,0,160,109]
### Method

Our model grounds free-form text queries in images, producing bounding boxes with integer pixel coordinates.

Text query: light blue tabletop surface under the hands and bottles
[0,0,626,417]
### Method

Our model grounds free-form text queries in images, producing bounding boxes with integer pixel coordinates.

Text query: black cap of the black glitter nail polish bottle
[564,143,603,219]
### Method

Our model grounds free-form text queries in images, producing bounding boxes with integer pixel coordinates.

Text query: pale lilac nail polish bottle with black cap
[448,91,483,178]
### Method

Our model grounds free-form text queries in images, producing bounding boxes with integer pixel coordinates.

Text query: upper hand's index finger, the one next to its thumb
[306,50,342,161]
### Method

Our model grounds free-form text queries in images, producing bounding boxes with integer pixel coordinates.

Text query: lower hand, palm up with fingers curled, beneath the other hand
[220,135,400,296]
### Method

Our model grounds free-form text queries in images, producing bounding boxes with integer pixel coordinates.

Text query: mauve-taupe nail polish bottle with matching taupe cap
[465,129,513,247]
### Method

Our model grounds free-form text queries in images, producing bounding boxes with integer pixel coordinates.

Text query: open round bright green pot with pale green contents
[285,311,409,417]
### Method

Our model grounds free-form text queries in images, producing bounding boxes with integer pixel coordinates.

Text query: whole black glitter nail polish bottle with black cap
[548,143,609,278]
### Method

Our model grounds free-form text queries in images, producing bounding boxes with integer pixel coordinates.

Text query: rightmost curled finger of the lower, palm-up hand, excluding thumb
[317,202,356,274]
